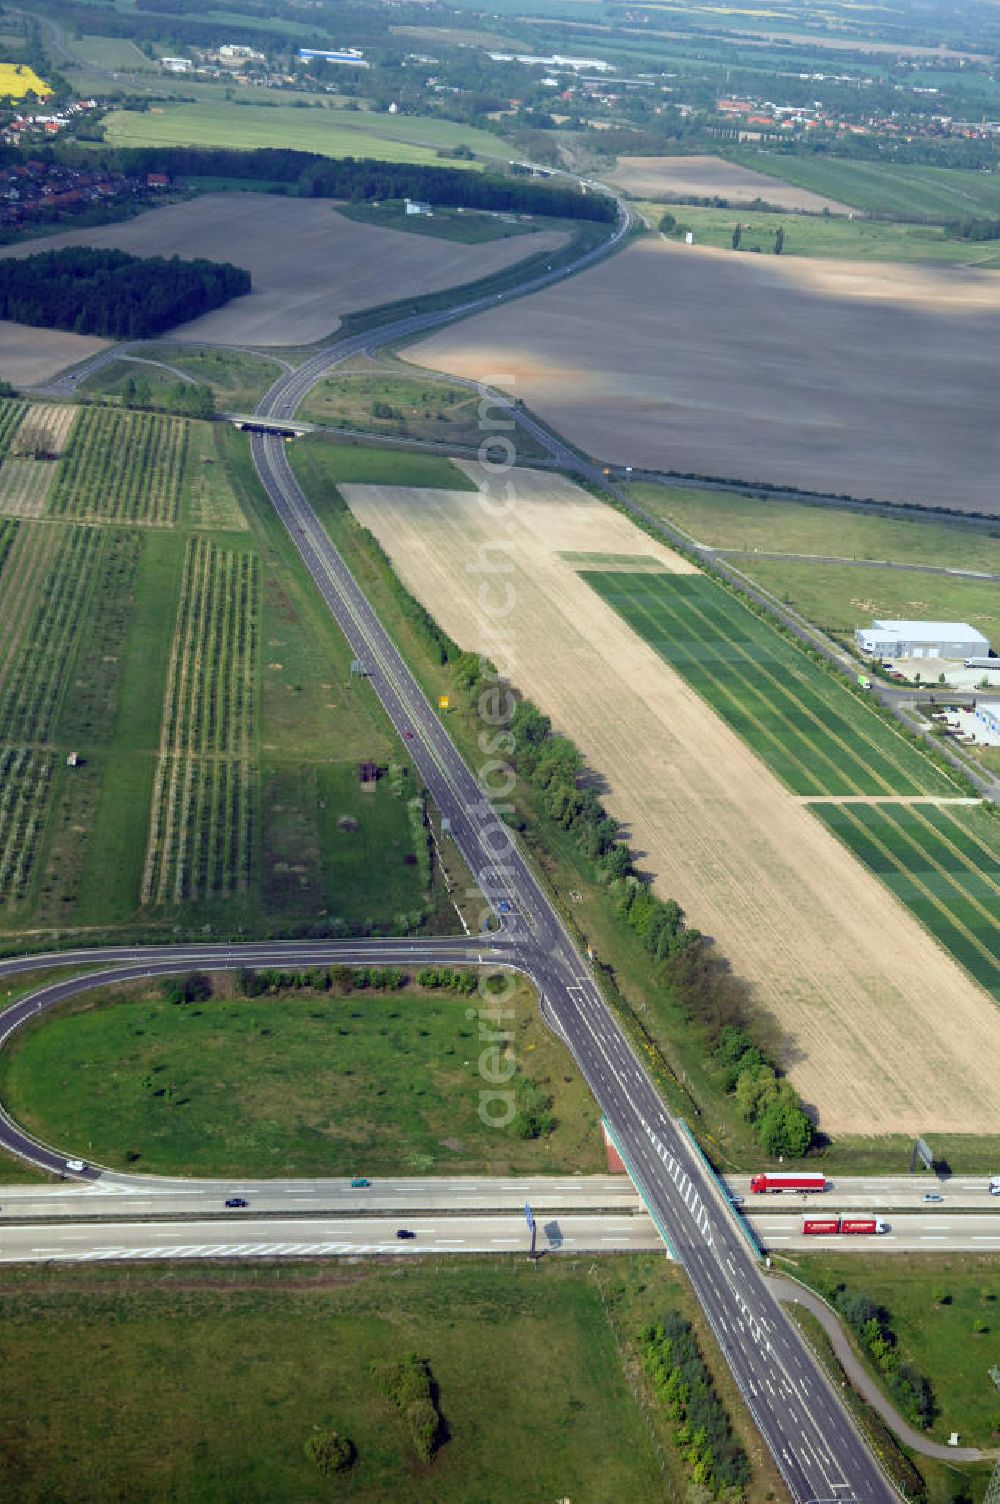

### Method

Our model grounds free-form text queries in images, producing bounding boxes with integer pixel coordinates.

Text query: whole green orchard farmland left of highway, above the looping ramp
[0,408,442,934]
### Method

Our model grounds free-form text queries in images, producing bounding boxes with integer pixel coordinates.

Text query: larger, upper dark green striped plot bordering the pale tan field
[582,570,962,796]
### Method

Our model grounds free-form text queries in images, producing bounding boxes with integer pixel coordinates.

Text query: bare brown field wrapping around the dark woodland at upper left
[0,193,567,344]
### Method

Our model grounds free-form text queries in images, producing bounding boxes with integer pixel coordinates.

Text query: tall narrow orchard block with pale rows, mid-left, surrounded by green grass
[141,538,260,904]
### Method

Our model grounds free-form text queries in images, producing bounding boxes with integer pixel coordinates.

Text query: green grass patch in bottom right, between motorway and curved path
[795,1254,1000,1448]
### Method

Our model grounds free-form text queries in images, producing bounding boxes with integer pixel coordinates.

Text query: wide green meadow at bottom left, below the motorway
[0,1257,763,1504]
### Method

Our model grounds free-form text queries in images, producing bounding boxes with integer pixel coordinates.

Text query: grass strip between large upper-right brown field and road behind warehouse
[630,483,1000,575]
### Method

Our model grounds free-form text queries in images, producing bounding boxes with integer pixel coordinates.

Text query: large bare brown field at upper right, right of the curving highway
[408,239,1000,513]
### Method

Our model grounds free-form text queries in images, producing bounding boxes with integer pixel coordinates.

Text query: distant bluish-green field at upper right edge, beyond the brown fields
[726,150,1000,221]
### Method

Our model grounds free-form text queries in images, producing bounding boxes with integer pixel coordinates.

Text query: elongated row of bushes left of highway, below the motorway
[641,1311,750,1498]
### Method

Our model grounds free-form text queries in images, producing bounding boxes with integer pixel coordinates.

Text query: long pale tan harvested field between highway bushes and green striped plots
[341,466,1000,1134]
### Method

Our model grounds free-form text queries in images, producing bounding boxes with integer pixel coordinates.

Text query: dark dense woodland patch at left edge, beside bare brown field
[0,247,250,340]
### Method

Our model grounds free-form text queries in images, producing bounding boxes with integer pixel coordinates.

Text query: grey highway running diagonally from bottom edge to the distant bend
[240,270,895,1504]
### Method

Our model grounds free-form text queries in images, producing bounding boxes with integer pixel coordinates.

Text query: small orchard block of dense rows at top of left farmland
[48,408,188,528]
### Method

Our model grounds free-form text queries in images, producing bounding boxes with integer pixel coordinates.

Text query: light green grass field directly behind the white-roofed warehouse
[724,559,1000,640]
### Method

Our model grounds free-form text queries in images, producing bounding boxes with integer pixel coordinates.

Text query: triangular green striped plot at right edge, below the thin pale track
[812,803,1000,1002]
